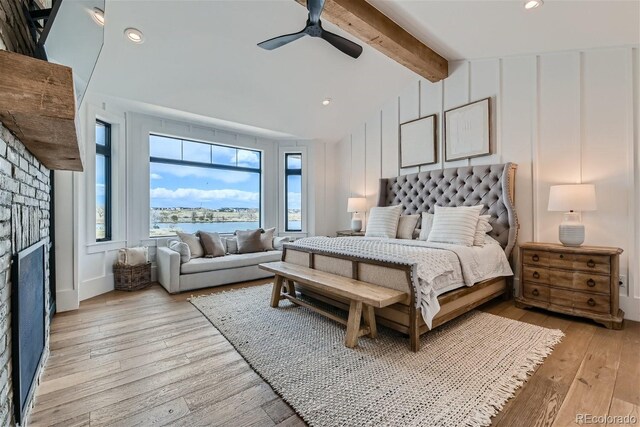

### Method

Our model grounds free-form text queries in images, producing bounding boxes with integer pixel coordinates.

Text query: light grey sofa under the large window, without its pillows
[156,246,282,294]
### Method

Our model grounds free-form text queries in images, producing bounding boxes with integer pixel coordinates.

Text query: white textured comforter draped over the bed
[292,237,513,329]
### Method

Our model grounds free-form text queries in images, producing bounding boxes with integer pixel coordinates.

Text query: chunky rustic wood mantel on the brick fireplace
[0,50,83,171]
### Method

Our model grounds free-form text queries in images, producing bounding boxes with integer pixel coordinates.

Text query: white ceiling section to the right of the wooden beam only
[370,0,640,61]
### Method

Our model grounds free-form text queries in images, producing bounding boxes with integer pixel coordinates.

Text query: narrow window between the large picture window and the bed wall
[284,153,302,231]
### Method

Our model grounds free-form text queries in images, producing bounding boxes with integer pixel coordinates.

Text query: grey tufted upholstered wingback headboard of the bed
[378,163,518,256]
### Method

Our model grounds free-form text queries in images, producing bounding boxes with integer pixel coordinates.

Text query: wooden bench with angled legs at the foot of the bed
[260,261,407,348]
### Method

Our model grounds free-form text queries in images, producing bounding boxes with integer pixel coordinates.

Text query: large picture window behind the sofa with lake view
[149,135,262,237]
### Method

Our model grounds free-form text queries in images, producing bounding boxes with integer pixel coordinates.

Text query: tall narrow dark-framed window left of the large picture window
[96,120,111,242]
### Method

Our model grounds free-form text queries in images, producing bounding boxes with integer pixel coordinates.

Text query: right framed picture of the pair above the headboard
[444,98,491,162]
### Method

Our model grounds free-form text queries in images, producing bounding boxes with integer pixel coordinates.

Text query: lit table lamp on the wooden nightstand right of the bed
[548,184,596,246]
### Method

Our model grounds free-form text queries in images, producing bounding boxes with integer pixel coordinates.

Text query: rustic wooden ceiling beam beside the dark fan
[296,0,449,82]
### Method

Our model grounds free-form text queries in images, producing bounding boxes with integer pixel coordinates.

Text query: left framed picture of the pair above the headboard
[400,114,438,168]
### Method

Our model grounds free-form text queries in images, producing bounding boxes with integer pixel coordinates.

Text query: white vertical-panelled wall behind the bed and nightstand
[331,46,640,319]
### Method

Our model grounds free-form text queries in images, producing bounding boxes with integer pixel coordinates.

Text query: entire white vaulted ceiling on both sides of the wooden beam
[90,0,640,145]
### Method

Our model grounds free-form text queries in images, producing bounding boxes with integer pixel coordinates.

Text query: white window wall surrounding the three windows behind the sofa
[56,97,327,311]
